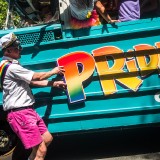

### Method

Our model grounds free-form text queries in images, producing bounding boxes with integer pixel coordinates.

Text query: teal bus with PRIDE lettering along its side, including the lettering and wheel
[0,0,160,156]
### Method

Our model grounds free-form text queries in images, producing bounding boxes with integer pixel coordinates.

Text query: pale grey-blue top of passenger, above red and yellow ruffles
[69,0,97,20]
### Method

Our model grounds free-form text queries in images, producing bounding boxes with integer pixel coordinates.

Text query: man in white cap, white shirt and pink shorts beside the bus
[0,33,66,160]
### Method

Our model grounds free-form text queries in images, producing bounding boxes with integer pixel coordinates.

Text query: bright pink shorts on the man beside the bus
[7,108,47,149]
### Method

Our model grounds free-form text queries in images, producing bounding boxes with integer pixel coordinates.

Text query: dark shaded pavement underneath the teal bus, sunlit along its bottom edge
[0,128,160,160]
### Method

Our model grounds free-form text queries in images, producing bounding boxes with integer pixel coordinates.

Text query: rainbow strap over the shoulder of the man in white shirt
[0,61,12,89]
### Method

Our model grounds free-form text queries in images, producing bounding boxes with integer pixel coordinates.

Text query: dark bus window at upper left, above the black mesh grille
[11,0,59,27]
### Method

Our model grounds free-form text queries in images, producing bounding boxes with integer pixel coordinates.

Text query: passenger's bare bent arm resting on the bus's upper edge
[95,1,119,23]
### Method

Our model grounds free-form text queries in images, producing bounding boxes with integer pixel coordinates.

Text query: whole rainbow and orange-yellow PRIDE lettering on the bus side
[57,42,160,103]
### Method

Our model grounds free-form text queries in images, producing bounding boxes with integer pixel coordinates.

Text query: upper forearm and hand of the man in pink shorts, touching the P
[32,66,65,81]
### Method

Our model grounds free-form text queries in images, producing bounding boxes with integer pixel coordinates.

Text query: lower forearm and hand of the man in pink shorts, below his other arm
[30,80,67,89]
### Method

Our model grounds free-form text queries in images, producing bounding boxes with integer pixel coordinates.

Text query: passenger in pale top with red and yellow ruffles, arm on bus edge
[69,0,120,29]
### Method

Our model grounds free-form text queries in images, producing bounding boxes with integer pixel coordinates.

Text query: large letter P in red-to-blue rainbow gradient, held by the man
[58,51,95,103]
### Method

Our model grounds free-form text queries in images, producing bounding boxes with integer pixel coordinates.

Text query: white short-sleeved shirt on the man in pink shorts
[1,57,35,111]
